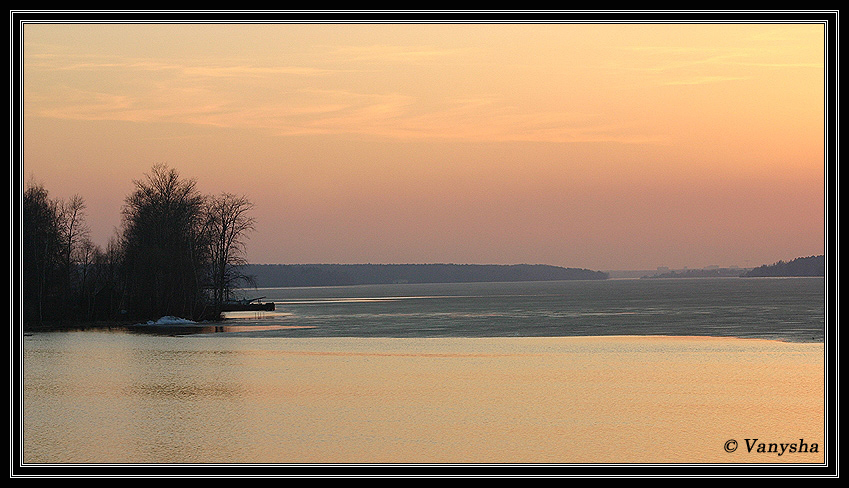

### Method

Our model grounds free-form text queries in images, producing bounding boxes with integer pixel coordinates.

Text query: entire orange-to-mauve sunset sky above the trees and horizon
[22,19,825,270]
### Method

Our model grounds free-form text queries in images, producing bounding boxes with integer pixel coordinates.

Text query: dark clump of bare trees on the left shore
[21,165,255,327]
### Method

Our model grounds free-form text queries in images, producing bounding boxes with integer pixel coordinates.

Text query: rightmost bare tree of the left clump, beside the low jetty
[206,193,256,309]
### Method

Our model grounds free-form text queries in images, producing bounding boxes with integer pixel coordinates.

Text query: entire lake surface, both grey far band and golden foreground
[22,278,827,465]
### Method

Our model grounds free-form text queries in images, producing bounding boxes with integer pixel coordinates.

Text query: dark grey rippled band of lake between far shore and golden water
[205,278,825,342]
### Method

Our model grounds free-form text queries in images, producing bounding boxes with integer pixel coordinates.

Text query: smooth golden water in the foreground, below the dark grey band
[24,333,825,463]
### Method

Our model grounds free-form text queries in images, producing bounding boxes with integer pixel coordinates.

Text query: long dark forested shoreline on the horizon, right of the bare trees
[243,264,609,288]
